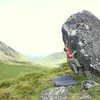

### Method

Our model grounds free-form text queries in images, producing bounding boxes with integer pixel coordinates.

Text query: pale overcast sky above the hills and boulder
[0,0,100,56]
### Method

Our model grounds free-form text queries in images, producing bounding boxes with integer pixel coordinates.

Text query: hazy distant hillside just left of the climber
[36,52,66,67]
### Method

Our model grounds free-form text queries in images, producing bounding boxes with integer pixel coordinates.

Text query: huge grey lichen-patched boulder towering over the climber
[62,10,100,74]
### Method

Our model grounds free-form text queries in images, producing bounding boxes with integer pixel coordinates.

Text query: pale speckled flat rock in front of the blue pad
[39,86,68,100]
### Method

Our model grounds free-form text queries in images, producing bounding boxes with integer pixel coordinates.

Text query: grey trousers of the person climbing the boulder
[68,58,80,74]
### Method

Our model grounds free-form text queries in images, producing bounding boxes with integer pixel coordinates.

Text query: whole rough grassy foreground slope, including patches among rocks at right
[0,63,100,100]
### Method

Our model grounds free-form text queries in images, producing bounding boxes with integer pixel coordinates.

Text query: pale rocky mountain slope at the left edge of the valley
[0,41,24,62]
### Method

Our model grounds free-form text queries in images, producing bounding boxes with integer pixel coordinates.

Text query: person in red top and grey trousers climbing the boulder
[64,47,81,74]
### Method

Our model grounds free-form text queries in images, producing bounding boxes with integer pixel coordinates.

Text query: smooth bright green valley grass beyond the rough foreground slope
[0,62,47,80]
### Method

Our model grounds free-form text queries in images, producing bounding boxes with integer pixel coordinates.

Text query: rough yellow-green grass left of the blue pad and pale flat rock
[0,62,71,100]
